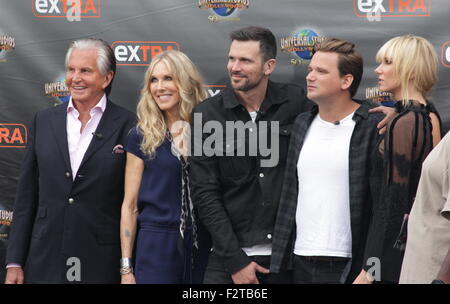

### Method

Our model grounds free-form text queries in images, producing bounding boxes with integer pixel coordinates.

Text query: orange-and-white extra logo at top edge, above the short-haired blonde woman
[353,0,431,18]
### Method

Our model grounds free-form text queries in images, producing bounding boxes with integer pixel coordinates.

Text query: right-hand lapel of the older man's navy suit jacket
[80,100,120,169]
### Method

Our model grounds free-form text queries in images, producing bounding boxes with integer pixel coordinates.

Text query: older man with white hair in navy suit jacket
[5,38,135,284]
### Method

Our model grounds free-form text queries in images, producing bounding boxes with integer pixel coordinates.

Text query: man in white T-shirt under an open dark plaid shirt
[270,39,383,284]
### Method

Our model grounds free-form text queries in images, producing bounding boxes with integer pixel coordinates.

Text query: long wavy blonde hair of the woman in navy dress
[136,50,206,158]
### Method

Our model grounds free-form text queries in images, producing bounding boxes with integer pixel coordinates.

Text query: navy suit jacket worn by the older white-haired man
[6,100,135,283]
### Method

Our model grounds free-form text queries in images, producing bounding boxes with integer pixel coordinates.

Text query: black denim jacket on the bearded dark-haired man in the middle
[190,81,312,273]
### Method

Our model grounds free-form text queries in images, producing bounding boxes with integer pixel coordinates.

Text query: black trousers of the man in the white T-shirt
[293,255,350,284]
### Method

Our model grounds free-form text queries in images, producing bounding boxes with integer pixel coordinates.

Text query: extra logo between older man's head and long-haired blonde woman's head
[112,41,180,66]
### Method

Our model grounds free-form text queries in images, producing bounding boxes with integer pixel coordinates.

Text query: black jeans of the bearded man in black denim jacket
[203,251,292,284]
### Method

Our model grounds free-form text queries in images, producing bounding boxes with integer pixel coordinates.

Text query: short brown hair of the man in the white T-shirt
[313,38,364,97]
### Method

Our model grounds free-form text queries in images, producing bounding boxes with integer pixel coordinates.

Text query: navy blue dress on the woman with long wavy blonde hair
[125,128,209,284]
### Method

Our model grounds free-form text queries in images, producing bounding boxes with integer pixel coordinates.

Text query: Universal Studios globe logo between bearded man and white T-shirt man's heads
[281,29,325,65]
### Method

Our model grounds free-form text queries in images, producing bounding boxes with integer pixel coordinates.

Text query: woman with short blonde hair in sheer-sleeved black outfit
[355,35,441,283]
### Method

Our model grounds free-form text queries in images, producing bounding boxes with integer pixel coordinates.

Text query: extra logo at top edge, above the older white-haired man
[32,0,101,21]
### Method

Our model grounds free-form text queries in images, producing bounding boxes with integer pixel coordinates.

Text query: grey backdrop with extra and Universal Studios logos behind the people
[0,0,450,279]
